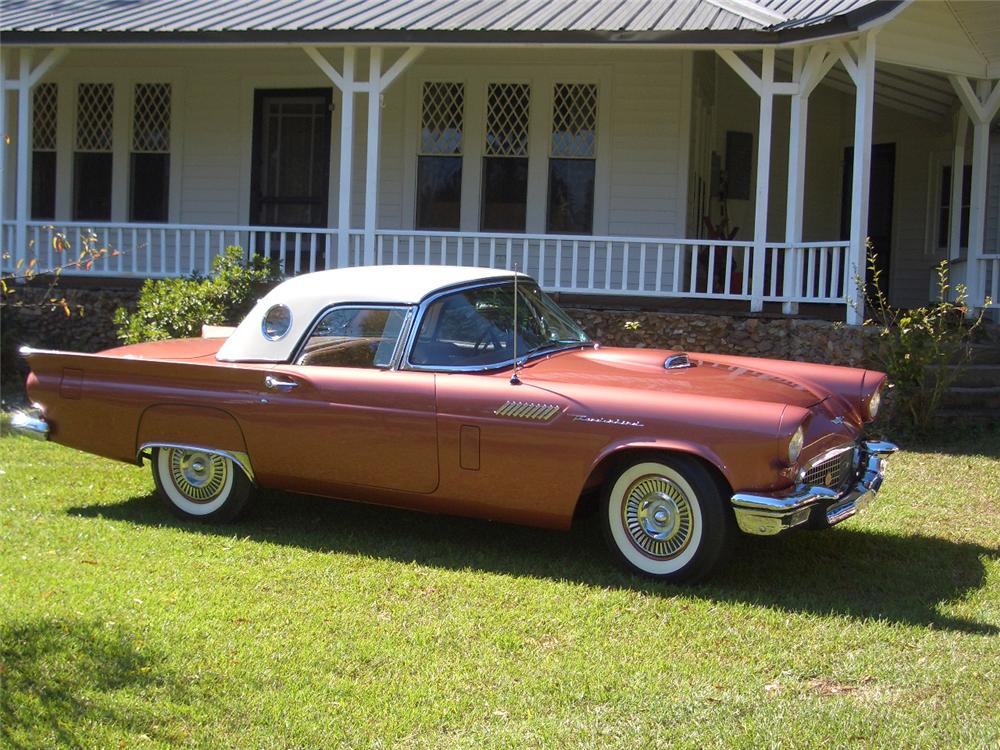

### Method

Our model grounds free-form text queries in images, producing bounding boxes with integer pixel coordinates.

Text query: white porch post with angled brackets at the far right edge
[950,76,1000,314]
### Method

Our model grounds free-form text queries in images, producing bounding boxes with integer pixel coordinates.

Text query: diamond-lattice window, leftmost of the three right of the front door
[415,81,465,229]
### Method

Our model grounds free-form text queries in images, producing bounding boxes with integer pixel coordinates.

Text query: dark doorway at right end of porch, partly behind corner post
[840,143,896,295]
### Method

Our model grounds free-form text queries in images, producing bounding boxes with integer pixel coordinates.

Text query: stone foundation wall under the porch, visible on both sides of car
[0,288,874,406]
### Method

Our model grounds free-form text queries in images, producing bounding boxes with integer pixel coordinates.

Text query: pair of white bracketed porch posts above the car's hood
[718,44,839,313]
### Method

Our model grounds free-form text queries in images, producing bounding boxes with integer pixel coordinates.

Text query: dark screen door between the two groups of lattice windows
[250,89,333,273]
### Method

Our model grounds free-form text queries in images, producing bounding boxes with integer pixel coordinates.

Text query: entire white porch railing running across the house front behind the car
[2,221,854,304]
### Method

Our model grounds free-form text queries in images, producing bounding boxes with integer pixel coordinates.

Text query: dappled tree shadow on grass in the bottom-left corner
[0,619,195,749]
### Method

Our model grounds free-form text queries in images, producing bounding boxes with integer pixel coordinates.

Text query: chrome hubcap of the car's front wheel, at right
[622,475,693,559]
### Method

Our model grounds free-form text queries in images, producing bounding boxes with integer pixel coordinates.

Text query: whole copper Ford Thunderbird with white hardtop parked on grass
[15,266,896,581]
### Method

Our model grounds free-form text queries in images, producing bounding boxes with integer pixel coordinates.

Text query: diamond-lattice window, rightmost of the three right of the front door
[546,83,597,234]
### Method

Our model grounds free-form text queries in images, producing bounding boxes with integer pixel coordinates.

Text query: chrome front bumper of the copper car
[731,440,898,536]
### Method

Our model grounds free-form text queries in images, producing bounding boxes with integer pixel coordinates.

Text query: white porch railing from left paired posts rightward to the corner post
[375,229,853,303]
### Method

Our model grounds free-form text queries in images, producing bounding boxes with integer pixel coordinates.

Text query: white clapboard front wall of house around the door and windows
[29,48,684,241]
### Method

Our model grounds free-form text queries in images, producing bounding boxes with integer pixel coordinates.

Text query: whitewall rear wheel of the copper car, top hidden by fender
[151,448,250,523]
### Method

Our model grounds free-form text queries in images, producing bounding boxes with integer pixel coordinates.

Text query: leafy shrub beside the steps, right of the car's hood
[859,251,983,434]
